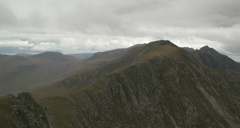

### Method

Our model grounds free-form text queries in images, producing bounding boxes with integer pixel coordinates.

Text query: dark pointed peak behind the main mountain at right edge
[192,46,240,71]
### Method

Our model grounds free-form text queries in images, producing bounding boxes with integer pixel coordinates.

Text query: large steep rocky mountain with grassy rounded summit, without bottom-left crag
[30,41,239,128]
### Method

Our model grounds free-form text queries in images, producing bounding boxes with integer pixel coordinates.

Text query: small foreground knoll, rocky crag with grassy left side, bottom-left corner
[0,92,54,128]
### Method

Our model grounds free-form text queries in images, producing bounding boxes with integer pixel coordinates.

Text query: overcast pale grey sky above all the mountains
[0,0,240,61]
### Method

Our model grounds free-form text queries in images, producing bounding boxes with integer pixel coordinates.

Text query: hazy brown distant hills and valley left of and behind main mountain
[0,47,135,96]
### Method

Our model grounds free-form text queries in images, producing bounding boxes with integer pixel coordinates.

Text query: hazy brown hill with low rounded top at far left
[0,52,80,95]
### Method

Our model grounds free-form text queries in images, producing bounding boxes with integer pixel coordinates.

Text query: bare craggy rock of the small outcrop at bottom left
[5,92,54,128]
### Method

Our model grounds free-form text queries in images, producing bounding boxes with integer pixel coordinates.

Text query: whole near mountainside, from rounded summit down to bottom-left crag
[0,40,240,128]
